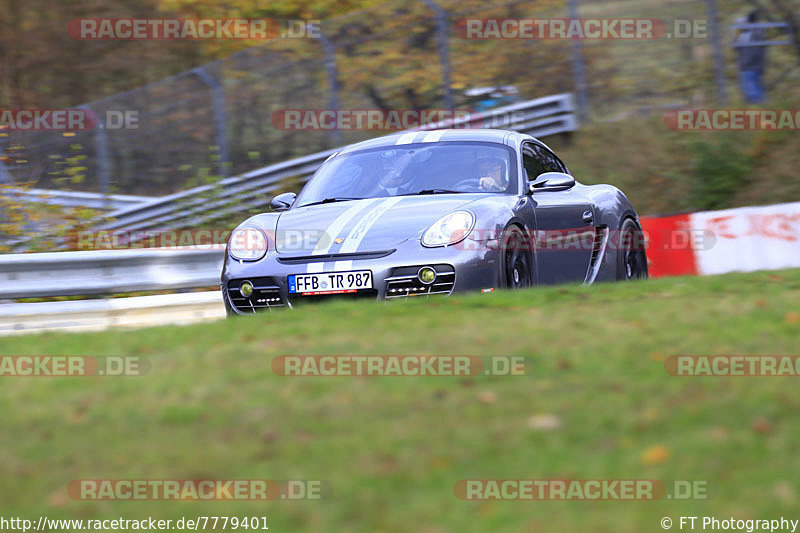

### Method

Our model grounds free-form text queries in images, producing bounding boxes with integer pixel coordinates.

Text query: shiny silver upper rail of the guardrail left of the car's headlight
[0,246,224,303]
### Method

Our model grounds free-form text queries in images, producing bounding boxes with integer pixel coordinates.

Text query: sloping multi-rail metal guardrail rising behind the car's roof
[100,93,578,230]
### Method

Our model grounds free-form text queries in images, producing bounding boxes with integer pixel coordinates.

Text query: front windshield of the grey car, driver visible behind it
[297,142,518,207]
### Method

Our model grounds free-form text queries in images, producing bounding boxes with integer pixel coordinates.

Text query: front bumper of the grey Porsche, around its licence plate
[222,237,500,314]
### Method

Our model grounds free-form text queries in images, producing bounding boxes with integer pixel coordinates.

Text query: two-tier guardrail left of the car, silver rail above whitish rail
[0,246,225,336]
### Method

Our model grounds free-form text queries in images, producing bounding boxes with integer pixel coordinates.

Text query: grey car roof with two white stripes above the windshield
[339,129,533,154]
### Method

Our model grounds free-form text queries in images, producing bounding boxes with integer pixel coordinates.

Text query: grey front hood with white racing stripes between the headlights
[275,194,486,255]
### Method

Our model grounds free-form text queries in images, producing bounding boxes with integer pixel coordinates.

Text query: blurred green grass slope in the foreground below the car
[0,270,800,533]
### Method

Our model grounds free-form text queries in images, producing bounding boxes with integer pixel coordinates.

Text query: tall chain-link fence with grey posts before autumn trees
[0,0,798,196]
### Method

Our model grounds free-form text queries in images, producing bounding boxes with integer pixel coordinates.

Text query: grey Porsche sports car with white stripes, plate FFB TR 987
[222,129,647,314]
